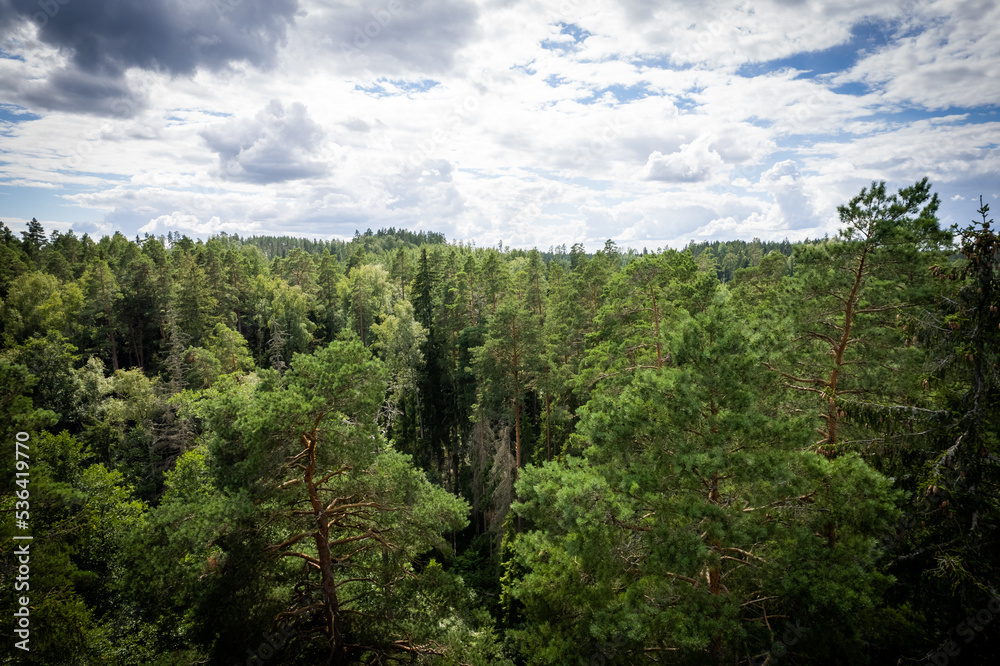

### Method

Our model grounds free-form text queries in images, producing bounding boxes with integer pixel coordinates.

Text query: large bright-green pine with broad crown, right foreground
[512,294,895,663]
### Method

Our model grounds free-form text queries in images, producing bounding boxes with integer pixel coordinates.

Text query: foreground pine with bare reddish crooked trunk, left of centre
[200,340,468,666]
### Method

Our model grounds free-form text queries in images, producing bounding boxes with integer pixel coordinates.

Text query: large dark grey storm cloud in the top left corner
[0,0,298,115]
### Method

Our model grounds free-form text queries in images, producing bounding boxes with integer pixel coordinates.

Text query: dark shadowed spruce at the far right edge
[864,196,1000,661]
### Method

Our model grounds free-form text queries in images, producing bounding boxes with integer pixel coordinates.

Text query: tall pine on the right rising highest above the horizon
[772,178,948,455]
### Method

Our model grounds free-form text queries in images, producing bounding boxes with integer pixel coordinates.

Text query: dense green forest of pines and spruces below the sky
[0,179,1000,666]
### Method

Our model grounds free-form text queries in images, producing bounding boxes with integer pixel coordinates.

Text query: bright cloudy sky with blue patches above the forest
[0,0,1000,250]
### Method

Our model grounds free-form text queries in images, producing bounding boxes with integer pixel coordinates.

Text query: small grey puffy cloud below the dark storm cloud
[201,100,329,184]
